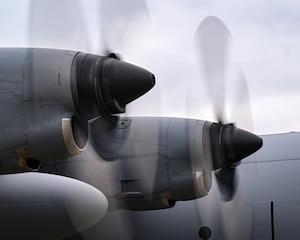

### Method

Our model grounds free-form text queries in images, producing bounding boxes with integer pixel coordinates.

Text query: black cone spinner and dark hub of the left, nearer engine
[72,53,155,120]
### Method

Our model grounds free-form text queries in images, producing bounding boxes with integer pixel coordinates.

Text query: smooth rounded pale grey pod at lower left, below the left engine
[0,173,108,240]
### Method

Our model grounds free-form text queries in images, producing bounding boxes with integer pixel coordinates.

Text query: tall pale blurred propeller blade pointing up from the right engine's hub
[195,17,230,123]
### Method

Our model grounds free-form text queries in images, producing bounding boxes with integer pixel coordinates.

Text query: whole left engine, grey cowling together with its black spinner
[0,48,155,173]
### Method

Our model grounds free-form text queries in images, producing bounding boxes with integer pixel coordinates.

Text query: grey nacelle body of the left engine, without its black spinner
[0,48,87,172]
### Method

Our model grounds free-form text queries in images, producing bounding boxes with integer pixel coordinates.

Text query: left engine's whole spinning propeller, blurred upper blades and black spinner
[28,0,155,236]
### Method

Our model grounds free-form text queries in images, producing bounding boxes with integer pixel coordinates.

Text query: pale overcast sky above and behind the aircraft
[0,0,300,134]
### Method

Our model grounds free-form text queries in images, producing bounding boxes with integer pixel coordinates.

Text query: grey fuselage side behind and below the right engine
[57,133,300,240]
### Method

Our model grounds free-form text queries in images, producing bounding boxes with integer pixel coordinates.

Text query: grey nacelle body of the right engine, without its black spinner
[93,117,212,210]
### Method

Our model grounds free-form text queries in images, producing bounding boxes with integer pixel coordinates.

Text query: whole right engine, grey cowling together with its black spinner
[41,117,262,210]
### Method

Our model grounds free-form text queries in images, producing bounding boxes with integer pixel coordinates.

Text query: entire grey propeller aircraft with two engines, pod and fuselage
[0,1,300,240]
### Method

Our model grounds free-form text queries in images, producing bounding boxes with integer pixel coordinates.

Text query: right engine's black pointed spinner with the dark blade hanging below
[210,123,263,201]
